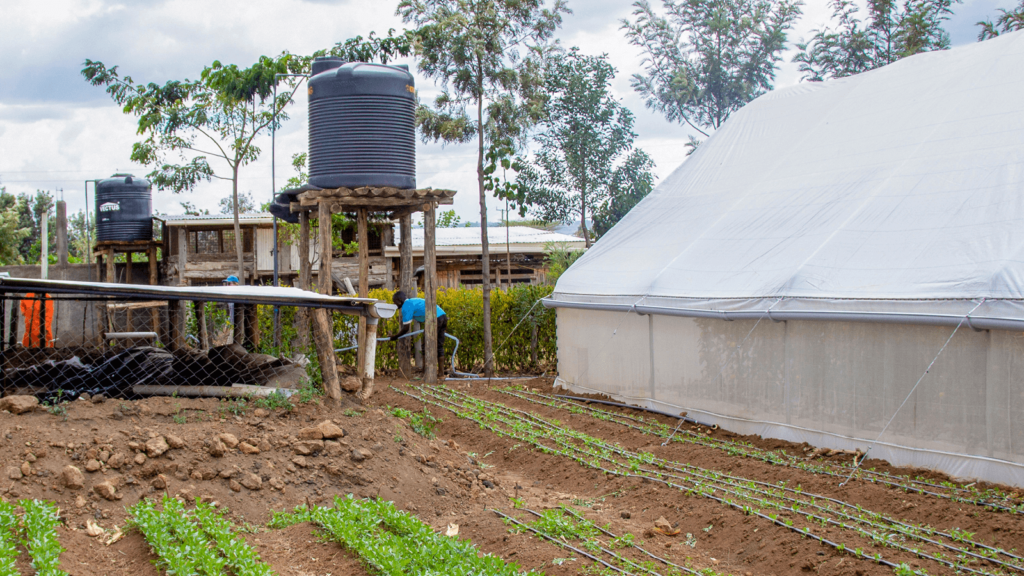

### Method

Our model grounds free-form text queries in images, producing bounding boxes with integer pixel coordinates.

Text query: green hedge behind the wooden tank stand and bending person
[252,285,557,373]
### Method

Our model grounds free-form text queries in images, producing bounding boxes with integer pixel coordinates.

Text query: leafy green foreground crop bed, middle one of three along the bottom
[128,495,273,576]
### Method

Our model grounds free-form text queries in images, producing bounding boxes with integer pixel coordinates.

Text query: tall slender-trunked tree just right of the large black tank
[397,0,569,375]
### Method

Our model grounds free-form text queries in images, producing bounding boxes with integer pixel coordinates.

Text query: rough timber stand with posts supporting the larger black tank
[292,187,456,400]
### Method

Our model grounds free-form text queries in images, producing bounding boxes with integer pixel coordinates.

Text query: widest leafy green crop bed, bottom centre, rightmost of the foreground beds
[269,494,540,576]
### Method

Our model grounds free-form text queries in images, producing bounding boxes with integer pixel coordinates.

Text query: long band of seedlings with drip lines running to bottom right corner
[399,388,1022,574]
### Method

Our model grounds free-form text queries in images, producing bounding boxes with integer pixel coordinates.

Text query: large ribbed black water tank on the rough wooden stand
[309,58,416,189]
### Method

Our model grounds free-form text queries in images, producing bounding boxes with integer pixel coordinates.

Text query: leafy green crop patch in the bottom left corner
[0,500,68,576]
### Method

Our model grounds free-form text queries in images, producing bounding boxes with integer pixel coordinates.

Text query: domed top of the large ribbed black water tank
[309,63,416,101]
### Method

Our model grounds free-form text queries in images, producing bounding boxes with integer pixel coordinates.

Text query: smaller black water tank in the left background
[96,174,153,242]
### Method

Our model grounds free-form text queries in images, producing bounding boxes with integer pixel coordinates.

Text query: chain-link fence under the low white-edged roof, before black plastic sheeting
[0,293,344,402]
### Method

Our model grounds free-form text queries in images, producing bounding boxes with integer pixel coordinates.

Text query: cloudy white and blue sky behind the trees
[0,0,1016,221]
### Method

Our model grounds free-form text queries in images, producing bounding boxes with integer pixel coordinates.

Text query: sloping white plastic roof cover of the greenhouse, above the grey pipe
[551,32,1024,321]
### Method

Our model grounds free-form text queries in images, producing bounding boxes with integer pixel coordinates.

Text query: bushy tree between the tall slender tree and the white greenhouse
[517,48,646,248]
